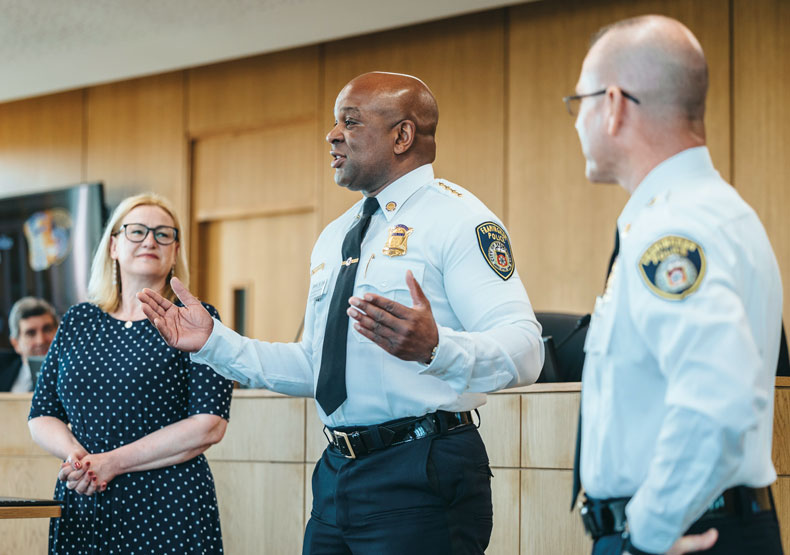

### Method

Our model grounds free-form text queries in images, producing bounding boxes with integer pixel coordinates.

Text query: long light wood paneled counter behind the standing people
[0,378,790,555]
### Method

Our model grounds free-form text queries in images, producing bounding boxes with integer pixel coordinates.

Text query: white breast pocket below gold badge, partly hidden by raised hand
[353,258,425,342]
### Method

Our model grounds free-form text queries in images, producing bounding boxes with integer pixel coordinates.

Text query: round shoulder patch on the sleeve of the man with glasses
[639,235,705,301]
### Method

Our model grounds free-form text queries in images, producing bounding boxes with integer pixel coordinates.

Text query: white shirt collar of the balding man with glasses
[617,146,716,238]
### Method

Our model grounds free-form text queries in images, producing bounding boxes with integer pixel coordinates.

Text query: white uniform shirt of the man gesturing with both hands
[193,165,543,427]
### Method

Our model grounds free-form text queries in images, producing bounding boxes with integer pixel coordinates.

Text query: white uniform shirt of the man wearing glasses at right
[581,147,782,553]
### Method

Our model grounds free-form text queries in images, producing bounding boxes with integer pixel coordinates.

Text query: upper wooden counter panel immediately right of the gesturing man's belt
[479,394,521,468]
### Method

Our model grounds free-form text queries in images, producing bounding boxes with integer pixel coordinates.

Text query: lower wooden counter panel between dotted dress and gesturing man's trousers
[211,461,304,555]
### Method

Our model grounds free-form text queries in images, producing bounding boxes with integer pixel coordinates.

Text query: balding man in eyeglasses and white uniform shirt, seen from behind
[564,11,782,555]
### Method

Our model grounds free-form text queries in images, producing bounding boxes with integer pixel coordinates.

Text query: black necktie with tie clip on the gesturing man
[315,197,379,416]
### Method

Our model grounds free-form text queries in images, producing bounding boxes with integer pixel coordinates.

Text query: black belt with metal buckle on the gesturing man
[324,410,473,459]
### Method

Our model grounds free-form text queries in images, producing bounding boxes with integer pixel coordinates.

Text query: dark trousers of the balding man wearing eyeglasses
[592,511,783,555]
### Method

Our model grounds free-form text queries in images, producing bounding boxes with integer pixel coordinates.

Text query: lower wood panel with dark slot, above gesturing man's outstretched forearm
[200,213,316,342]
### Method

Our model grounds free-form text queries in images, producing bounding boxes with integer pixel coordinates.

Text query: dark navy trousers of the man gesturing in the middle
[302,426,493,555]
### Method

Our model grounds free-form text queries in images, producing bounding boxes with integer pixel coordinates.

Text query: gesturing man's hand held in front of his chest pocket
[347,270,439,364]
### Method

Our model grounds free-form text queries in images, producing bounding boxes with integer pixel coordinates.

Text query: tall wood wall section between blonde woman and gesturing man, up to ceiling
[188,47,320,326]
